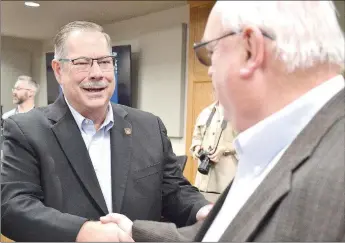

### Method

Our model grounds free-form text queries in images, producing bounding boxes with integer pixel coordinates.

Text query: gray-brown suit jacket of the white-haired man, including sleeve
[133,90,345,242]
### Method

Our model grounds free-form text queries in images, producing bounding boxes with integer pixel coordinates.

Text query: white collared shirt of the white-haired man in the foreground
[203,75,344,242]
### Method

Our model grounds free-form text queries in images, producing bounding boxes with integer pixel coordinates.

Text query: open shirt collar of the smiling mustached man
[65,97,114,131]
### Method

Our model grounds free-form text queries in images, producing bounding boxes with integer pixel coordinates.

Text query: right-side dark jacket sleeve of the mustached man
[158,118,210,227]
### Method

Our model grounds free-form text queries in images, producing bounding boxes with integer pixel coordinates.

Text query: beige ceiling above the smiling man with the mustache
[1,1,187,39]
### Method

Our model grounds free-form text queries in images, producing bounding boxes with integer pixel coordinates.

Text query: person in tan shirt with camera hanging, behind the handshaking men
[190,98,237,202]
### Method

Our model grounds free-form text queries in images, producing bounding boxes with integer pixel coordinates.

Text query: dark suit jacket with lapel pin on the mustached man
[1,97,208,241]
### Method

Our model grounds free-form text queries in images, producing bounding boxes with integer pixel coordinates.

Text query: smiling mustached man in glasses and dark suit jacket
[1,21,209,242]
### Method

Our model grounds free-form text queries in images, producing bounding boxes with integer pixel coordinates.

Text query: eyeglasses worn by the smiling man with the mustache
[59,56,115,72]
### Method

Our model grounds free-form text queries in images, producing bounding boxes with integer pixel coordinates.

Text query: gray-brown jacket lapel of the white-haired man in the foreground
[220,90,344,242]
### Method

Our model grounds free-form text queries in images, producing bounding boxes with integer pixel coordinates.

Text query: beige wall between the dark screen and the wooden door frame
[104,5,189,155]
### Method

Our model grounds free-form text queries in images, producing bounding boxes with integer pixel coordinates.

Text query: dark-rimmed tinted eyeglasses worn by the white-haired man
[193,30,274,67]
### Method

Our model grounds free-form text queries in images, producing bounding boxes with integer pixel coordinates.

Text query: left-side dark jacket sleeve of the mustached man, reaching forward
[1,117,87,241]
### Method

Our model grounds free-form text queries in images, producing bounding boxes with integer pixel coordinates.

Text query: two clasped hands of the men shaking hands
[76,213,134,242]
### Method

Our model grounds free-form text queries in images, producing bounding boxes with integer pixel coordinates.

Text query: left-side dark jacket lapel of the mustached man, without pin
[47,96,108,214]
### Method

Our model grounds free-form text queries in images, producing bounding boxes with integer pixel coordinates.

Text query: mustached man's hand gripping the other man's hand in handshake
[76,221,133,242]
